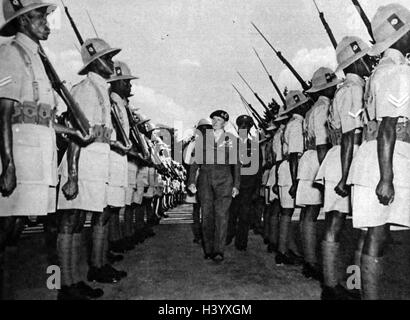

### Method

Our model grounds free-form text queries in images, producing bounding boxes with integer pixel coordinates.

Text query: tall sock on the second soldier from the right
[322,241,340,288]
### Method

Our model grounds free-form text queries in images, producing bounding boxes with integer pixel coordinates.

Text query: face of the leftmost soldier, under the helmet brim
[21,8,51,41]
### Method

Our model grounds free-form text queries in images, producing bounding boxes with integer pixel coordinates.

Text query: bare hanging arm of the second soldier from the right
[335,130,355,198]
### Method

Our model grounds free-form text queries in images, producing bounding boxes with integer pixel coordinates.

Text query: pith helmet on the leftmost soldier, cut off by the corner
[0,0,57,37]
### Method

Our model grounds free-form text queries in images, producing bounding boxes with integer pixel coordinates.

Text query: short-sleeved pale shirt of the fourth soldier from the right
[283,114,304,156]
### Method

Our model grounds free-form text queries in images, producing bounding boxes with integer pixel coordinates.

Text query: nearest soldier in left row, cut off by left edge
[0,0,91,297]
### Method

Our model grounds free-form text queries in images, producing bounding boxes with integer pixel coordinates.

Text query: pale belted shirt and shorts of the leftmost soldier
[0,33,57,216]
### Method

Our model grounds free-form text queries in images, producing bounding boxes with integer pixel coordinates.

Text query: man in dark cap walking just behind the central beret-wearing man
[227,115,262,251]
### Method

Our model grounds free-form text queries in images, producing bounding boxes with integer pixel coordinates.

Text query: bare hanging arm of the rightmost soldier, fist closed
[376,117,398,206]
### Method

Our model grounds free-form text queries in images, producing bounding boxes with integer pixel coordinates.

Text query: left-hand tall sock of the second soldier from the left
[57,233,73,286]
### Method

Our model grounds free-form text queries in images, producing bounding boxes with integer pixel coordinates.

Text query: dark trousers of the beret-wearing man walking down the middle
[198,165,233,254]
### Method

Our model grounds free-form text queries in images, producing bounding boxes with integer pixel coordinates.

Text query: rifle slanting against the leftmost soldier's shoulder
[39,45,91,136]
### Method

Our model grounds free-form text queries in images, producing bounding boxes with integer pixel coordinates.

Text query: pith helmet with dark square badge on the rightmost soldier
[369,3,410,56]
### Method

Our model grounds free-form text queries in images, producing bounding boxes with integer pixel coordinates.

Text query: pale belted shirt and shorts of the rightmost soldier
[349,49,410,228]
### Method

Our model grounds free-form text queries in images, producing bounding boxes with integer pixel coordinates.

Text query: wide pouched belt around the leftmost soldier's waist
[12,101,55,127]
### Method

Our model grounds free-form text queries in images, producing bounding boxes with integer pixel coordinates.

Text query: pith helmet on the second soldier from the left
[78,38,121,75]
